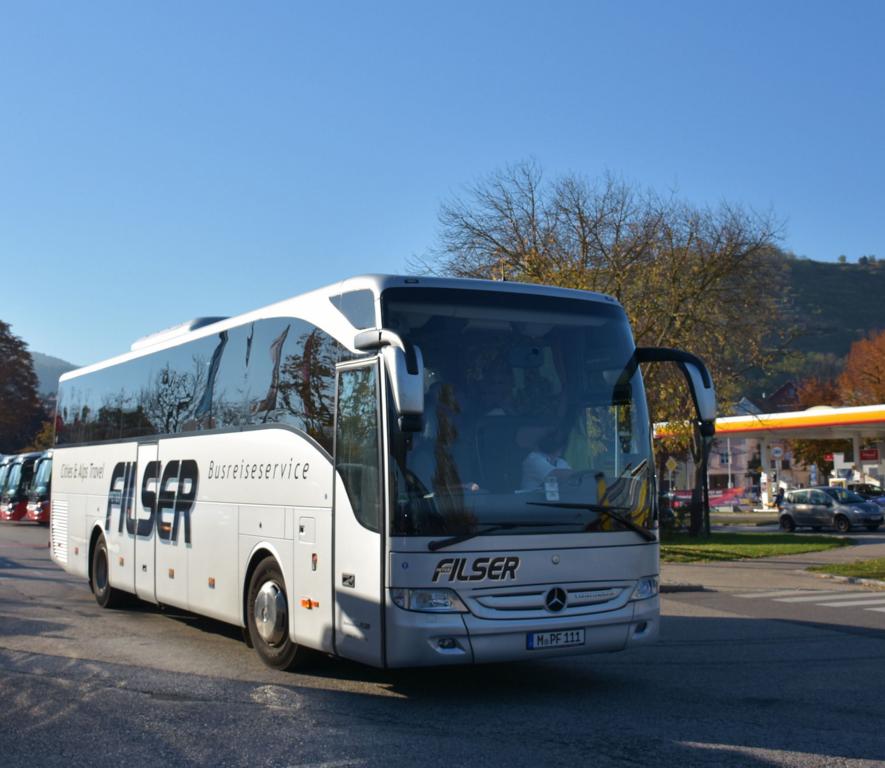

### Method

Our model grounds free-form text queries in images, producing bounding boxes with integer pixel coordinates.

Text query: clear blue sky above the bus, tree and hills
[0,0,885,364]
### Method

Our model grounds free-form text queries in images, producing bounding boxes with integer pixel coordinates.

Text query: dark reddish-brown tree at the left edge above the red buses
[0,320,45,453]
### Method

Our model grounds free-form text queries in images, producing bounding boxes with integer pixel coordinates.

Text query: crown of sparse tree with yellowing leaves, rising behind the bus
[412,162,788,432]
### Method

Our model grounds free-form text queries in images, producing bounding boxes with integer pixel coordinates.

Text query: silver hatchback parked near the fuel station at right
[780,486,883,533]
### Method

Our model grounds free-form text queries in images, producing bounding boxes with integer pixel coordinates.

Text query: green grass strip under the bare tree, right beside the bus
[661,533,851,563]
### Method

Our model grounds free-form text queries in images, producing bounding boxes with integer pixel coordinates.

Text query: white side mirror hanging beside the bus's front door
[353,328,424,432]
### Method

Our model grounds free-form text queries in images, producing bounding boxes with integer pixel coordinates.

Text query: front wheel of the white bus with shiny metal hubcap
[246,557,299,670]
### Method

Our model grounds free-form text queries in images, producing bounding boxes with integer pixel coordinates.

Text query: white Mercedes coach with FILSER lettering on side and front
[51,276,715,669]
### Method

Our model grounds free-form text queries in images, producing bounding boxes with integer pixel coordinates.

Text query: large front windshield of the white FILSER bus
[382,288,654,543]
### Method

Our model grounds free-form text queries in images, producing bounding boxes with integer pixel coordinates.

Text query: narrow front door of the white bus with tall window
[333,358,384,666]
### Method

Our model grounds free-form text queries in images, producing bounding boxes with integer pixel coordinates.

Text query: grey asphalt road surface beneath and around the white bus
[0,524,885,768]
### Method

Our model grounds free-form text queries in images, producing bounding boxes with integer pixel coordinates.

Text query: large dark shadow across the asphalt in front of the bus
[0,615,885,768]
